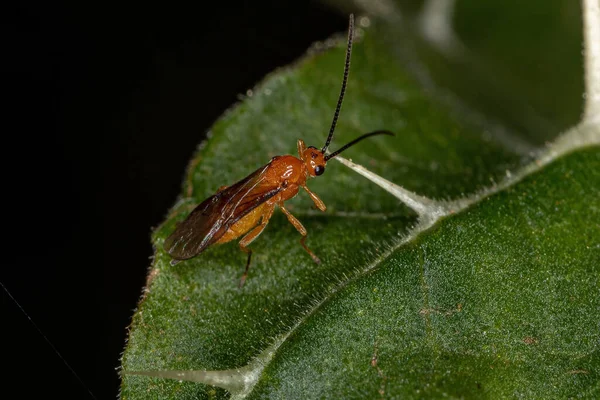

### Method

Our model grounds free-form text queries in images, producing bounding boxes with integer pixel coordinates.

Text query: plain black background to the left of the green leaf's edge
[0,0,347,399]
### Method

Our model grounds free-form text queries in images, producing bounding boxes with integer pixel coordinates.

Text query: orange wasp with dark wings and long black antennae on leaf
[164,15,393,287]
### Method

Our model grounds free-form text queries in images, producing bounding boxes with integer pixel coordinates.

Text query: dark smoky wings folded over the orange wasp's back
[164,164,281,260]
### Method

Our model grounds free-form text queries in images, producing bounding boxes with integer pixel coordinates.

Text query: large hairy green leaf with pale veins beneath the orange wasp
[121,0,600,399]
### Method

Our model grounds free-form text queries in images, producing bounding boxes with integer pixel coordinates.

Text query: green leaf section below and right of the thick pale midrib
[251,148,600,398]
